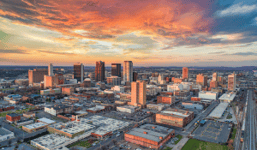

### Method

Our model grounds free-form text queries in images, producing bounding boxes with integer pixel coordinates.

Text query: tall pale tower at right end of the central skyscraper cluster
[123,61,133,82]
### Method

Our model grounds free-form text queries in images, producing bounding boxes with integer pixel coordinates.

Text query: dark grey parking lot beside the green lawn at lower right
[192,121,231,144]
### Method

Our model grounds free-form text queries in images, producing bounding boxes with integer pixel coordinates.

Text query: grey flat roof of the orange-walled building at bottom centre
[127,124,173,142]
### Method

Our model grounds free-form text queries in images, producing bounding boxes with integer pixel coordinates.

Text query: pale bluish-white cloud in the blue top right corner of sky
[217,3,257,17]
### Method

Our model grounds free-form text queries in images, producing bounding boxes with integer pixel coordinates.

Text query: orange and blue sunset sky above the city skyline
[0,0,257,67]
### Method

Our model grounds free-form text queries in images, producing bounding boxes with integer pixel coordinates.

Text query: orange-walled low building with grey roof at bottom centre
[124,124,175,149]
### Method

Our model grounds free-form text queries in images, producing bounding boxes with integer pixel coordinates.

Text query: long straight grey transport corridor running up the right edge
[243,90,256,150]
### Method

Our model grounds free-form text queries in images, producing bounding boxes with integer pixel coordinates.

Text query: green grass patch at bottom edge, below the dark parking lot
[181,139,228,150]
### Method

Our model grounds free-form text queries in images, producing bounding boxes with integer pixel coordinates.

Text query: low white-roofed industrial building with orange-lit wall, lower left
[48,118,95,138]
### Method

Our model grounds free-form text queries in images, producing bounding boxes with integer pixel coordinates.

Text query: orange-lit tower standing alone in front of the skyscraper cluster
[130,80,146,107]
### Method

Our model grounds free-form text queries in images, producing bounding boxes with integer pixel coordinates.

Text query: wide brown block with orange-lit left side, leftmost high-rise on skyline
[28,69,47,85]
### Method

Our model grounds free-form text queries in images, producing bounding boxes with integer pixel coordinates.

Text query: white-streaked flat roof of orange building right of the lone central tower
[159,108,193,118]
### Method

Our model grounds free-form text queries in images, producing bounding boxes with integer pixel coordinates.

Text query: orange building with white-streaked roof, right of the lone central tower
[155,108,194,128]
